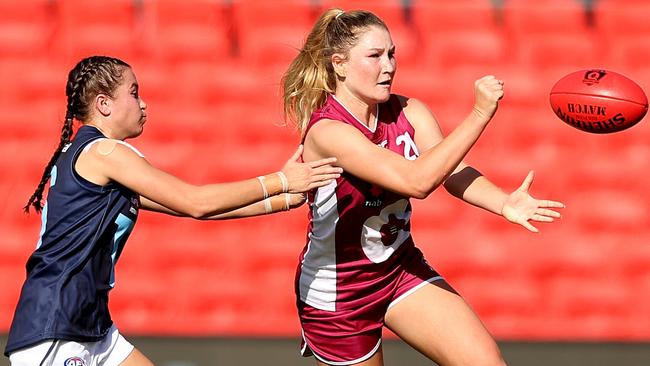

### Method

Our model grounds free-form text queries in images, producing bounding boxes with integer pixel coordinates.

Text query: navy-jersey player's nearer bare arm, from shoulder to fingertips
[75,140,341,218]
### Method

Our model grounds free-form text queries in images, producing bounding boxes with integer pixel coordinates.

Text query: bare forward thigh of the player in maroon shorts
[385,280,504,365]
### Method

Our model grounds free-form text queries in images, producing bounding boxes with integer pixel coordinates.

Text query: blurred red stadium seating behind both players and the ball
[0,0,650,366]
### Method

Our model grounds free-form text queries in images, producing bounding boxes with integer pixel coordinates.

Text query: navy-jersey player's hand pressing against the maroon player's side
[282,145,343,193]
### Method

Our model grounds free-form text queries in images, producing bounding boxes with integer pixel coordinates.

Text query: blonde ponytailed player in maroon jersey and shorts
[283,9,563,366]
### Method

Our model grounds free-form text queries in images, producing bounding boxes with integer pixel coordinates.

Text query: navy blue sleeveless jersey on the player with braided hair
[5,126,139,355]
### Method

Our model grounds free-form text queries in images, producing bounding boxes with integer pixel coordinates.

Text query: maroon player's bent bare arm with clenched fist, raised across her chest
[305,77,503,198]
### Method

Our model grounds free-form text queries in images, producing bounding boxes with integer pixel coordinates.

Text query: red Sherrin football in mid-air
[550,69,648,133]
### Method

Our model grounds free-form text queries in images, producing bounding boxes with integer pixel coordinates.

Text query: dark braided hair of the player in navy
[24,56,130,213]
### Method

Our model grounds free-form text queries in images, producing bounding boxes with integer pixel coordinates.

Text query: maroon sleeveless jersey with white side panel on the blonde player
[296,95,419,311]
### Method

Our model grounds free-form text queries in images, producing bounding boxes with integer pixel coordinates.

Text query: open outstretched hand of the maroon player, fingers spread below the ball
[501,171,564,233]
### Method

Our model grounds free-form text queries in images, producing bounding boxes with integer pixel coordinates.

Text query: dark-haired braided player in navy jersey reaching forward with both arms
[5,56,341,366]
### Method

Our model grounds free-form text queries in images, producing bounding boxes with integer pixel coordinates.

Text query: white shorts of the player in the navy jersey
[9,325,133,366]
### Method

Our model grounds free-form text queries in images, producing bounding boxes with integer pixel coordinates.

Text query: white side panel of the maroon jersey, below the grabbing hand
[299,180,339,311]
